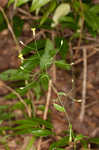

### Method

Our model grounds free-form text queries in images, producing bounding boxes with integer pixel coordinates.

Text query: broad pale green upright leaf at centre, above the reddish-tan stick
[40,39,56,70]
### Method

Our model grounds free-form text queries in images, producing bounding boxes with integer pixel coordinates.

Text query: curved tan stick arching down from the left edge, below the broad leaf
[4,83,30,116]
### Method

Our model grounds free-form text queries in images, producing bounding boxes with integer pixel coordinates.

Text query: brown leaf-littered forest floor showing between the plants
[0,19,99,150]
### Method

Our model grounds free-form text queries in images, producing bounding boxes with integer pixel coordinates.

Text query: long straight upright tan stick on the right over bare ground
[79,48,87,122]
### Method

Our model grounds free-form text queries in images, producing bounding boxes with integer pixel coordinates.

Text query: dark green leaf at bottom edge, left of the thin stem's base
[49,136,69,150]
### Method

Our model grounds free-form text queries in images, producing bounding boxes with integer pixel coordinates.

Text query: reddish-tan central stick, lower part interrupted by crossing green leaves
[37,80,52,150]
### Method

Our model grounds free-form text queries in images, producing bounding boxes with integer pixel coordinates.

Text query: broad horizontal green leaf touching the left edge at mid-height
[0,69,29,81]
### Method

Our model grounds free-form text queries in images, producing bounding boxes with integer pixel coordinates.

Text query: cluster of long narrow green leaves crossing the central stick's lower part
[12,117,53,136]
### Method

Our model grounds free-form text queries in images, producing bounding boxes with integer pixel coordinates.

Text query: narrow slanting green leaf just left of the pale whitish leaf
[40,0,56,25]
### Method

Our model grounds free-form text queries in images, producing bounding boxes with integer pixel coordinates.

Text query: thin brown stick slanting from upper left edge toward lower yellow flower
[0,6,20,52]
